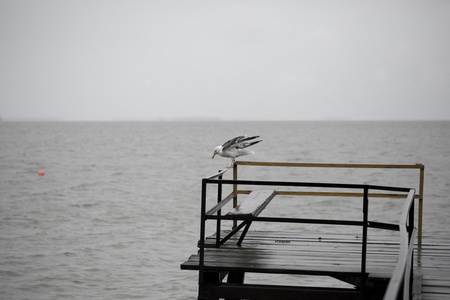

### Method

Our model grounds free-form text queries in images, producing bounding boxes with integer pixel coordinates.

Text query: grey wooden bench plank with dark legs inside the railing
[220,190,277,245]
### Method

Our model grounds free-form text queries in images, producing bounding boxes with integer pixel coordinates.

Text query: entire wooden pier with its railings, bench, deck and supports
[181,162,450,300]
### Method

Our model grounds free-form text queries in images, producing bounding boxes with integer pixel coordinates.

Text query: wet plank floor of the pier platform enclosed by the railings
[181,231,399,284]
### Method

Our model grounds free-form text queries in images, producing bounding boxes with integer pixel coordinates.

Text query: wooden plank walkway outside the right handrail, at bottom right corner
[415,236,450,300]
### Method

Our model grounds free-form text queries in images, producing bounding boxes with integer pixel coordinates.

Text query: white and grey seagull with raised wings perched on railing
[212,135,262,168]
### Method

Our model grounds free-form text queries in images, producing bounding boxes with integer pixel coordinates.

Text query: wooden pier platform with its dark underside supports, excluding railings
[181,232,399,299]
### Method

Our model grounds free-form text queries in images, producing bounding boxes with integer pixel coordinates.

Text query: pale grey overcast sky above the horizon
[0,0,450,120]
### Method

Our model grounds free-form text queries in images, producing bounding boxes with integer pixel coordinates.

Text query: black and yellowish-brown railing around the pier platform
[199,162,424,299]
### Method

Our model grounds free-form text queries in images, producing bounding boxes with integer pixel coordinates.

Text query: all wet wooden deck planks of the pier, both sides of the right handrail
[181,231,450,300]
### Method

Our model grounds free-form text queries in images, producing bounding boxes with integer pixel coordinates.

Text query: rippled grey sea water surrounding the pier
[0,121,450,299]
